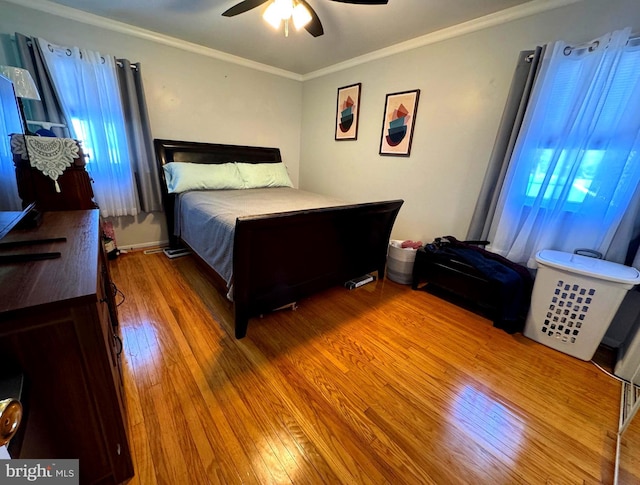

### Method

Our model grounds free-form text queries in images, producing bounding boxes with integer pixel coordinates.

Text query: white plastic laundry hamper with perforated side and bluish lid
[524,249,640,360]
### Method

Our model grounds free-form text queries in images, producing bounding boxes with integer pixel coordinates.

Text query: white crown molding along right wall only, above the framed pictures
[302,0,583,81]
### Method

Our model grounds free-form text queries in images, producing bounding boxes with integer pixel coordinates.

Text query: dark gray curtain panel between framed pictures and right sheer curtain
[467,47,544,240]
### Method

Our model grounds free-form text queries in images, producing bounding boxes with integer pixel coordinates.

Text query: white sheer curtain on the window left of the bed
[38,39,140,216]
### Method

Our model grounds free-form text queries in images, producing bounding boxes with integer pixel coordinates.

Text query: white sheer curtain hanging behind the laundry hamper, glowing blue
[489,29,640,267]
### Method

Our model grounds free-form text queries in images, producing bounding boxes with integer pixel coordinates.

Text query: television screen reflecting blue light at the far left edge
[0,75,24,211]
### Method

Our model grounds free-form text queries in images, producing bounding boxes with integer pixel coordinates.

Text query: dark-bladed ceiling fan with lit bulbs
[222,0,389,37]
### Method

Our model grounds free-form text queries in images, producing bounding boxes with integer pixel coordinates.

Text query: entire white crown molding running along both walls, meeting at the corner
[2,0,583,82]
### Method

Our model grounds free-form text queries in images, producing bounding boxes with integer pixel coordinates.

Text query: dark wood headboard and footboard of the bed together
[154,139,403,339]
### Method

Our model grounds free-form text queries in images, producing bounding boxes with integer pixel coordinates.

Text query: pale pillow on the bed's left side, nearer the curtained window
[162,162,244,194]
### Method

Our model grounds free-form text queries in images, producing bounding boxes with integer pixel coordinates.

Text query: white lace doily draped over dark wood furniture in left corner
[11,135,78,192]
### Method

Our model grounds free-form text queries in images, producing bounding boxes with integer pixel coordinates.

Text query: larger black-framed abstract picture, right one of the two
[380,89,420,157]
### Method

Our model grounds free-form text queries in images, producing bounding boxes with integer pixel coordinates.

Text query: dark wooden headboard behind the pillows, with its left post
[153,138,282,247]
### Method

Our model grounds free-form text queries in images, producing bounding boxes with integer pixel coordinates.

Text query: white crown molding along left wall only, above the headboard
[2,0,302,81]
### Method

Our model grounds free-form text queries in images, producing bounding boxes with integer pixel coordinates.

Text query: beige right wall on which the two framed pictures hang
[300,0,640,242]
